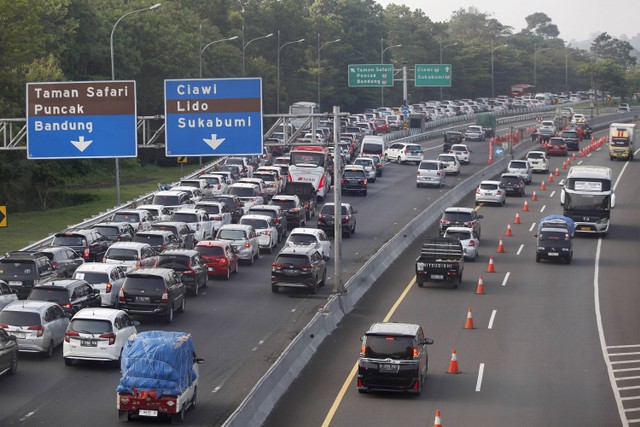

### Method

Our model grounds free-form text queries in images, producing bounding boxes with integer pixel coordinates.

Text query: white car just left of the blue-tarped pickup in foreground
[62,308,140,366]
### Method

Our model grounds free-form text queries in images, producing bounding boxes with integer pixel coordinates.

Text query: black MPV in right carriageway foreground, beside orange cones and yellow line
[357,323,433,394]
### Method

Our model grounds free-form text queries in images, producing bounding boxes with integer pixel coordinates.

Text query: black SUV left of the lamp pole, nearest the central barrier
[271,247,327,294]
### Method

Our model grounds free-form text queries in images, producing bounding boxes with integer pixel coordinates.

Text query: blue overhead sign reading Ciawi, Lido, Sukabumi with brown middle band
[164,78,263,157]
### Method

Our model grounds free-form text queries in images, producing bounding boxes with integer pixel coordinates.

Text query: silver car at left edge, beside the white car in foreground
[0,300,70,357]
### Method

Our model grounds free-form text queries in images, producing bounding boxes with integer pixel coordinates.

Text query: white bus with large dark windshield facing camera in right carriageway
[560,166,616,234]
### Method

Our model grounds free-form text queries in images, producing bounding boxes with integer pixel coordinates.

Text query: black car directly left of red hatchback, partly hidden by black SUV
[156,249,209,296]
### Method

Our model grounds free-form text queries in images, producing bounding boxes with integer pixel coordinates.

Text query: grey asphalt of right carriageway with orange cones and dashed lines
[265,131,640,427]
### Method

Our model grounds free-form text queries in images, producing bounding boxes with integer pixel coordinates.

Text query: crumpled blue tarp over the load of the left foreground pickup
[117,331,196,397]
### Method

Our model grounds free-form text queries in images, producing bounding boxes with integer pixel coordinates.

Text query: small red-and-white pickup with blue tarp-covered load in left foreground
[116,331,204,424]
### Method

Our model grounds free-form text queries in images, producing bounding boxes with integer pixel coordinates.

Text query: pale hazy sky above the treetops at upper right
[376,0,640,42]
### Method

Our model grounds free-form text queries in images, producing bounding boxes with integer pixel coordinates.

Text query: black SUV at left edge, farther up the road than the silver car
[0,251,58,299]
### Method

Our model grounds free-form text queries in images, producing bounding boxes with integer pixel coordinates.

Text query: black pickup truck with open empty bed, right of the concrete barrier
[416,237,464,289]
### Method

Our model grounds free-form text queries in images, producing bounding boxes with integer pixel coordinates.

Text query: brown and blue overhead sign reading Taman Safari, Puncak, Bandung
[27,80,138,159]
